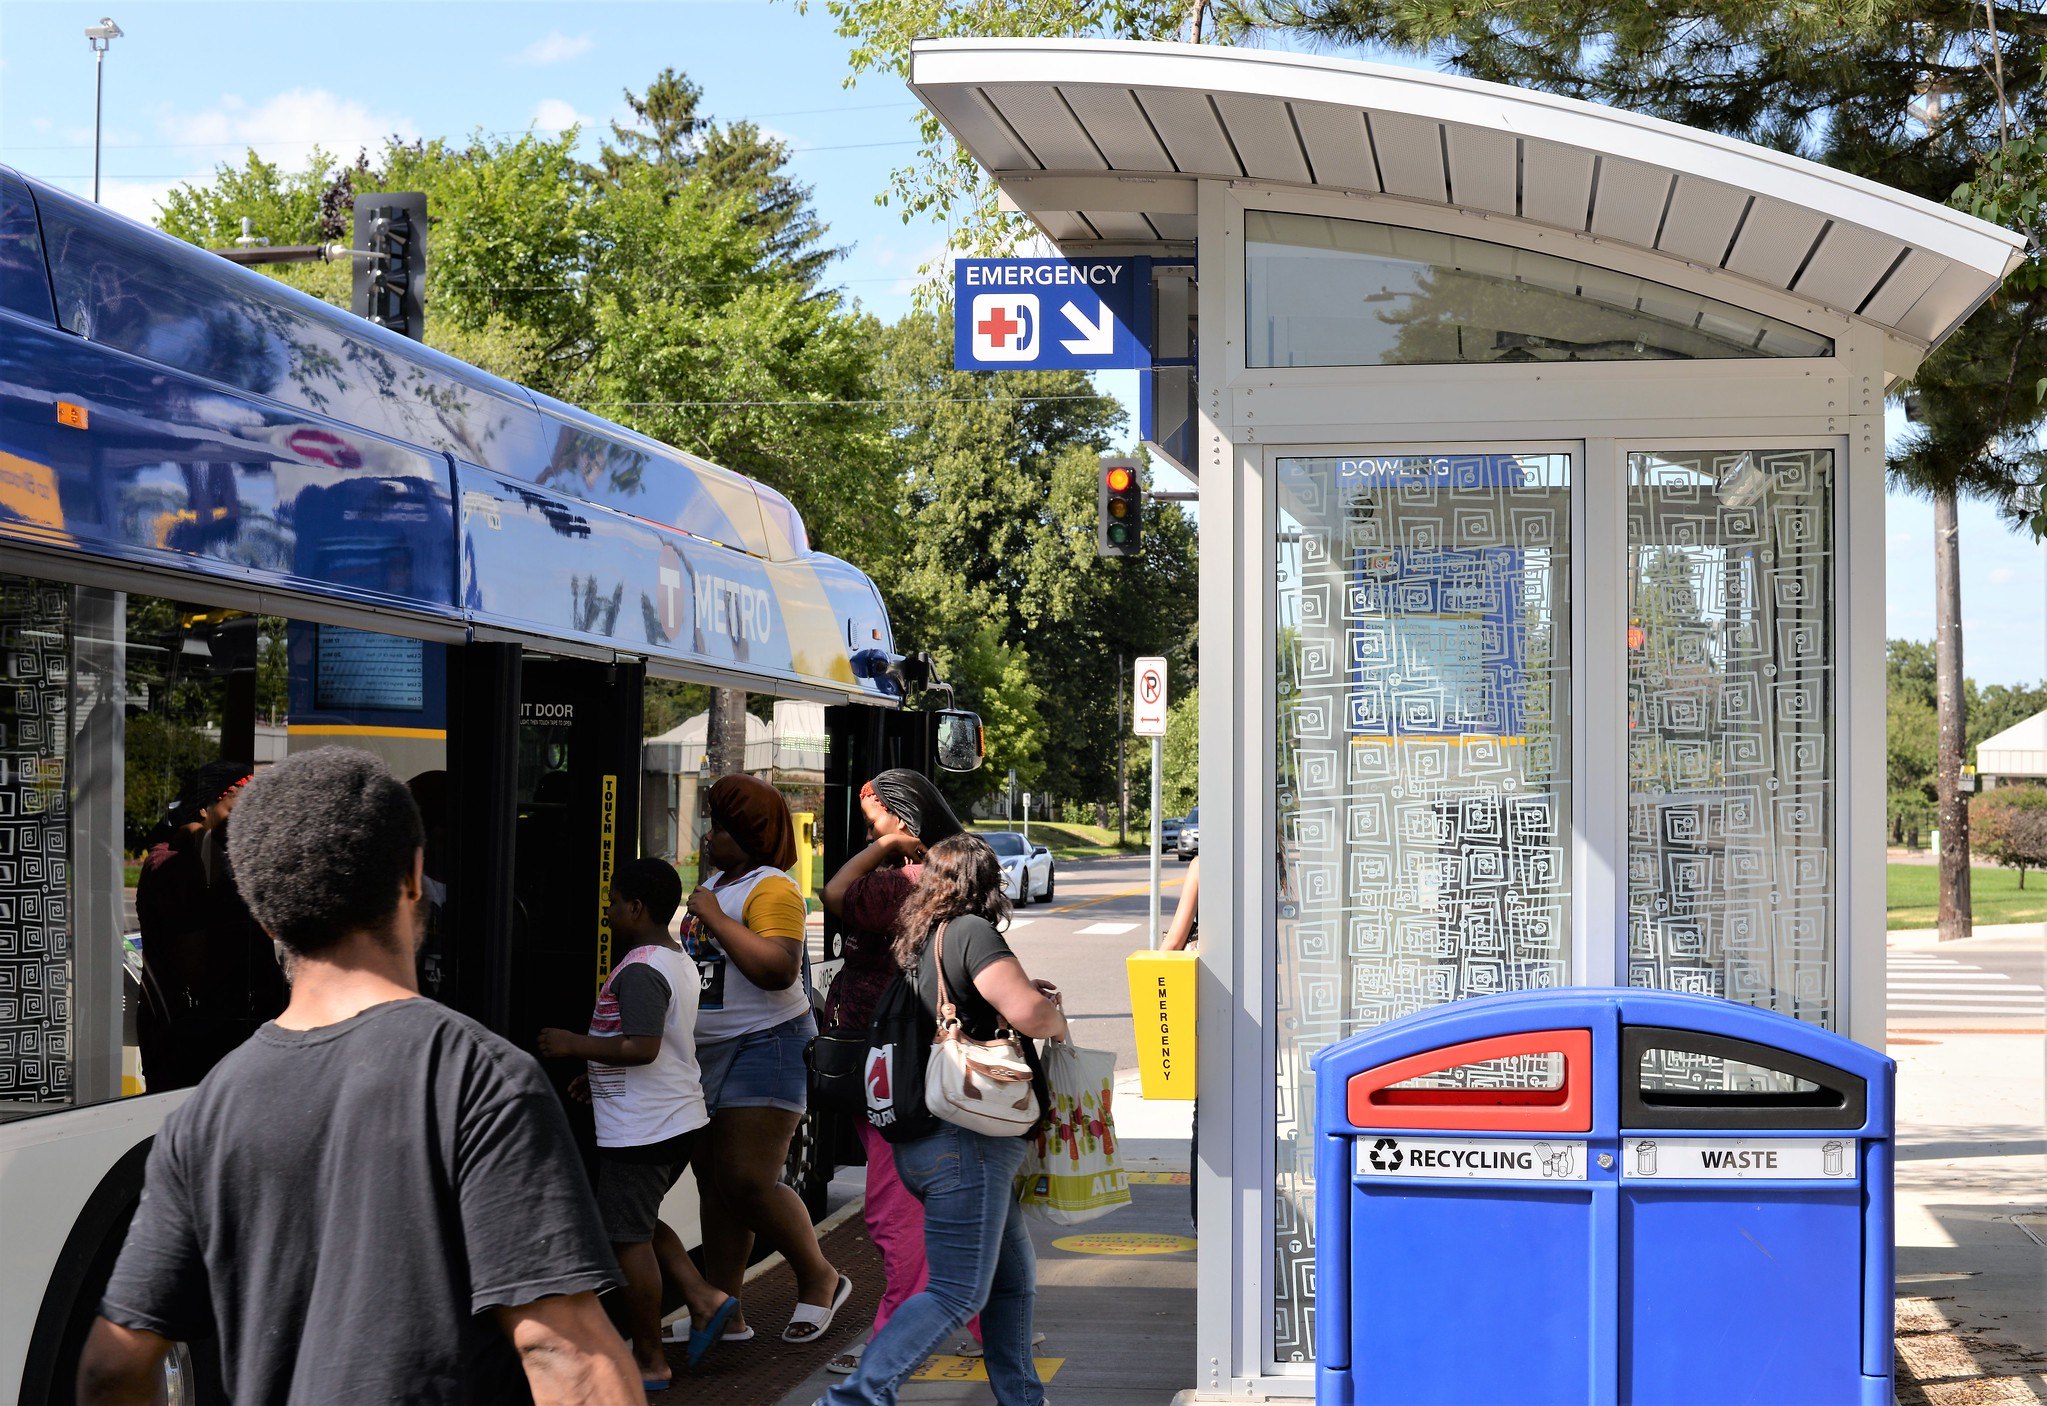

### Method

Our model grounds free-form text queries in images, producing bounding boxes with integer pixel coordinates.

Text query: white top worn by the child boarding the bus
[590,943,710,1148]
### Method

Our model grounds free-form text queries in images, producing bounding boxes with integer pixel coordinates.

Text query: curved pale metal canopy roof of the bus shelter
[911,39,2022,358]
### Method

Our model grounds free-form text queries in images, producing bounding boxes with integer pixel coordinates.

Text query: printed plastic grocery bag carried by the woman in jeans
[1017,1042,1130,1226]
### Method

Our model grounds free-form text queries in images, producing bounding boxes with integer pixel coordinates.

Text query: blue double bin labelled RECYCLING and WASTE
[1314,986,1896,1406]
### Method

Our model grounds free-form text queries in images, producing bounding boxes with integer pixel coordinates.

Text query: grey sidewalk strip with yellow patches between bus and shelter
[782,1070,1195,1406]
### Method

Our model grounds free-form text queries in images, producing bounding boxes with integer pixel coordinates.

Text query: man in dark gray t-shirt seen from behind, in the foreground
[78,747,645,1406]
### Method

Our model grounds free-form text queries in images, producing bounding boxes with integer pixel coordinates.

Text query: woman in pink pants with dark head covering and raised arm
[823,770,981,1375]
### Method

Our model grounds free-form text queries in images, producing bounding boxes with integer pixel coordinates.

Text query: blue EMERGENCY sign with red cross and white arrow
[952,258,1152,370]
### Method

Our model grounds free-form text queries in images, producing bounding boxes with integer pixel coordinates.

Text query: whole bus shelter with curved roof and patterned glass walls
[911,39,2020,1398]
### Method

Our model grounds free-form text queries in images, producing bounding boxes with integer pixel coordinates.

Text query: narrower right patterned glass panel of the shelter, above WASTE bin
[1627,450,1838,1089]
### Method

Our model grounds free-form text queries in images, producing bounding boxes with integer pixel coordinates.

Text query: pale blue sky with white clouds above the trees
[0,0,2047,684]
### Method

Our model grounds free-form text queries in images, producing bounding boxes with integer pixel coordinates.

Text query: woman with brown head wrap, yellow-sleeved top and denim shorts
[682,776,854,1343]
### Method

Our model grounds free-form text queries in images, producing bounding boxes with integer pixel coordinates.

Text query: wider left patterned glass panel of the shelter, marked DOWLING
[1273,454,1570,1363]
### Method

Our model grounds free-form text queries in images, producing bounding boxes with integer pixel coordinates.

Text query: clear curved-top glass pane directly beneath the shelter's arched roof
[1245,211,1834,366]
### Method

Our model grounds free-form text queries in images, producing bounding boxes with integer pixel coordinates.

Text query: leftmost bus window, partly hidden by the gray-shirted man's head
[0,575,446,1117]
